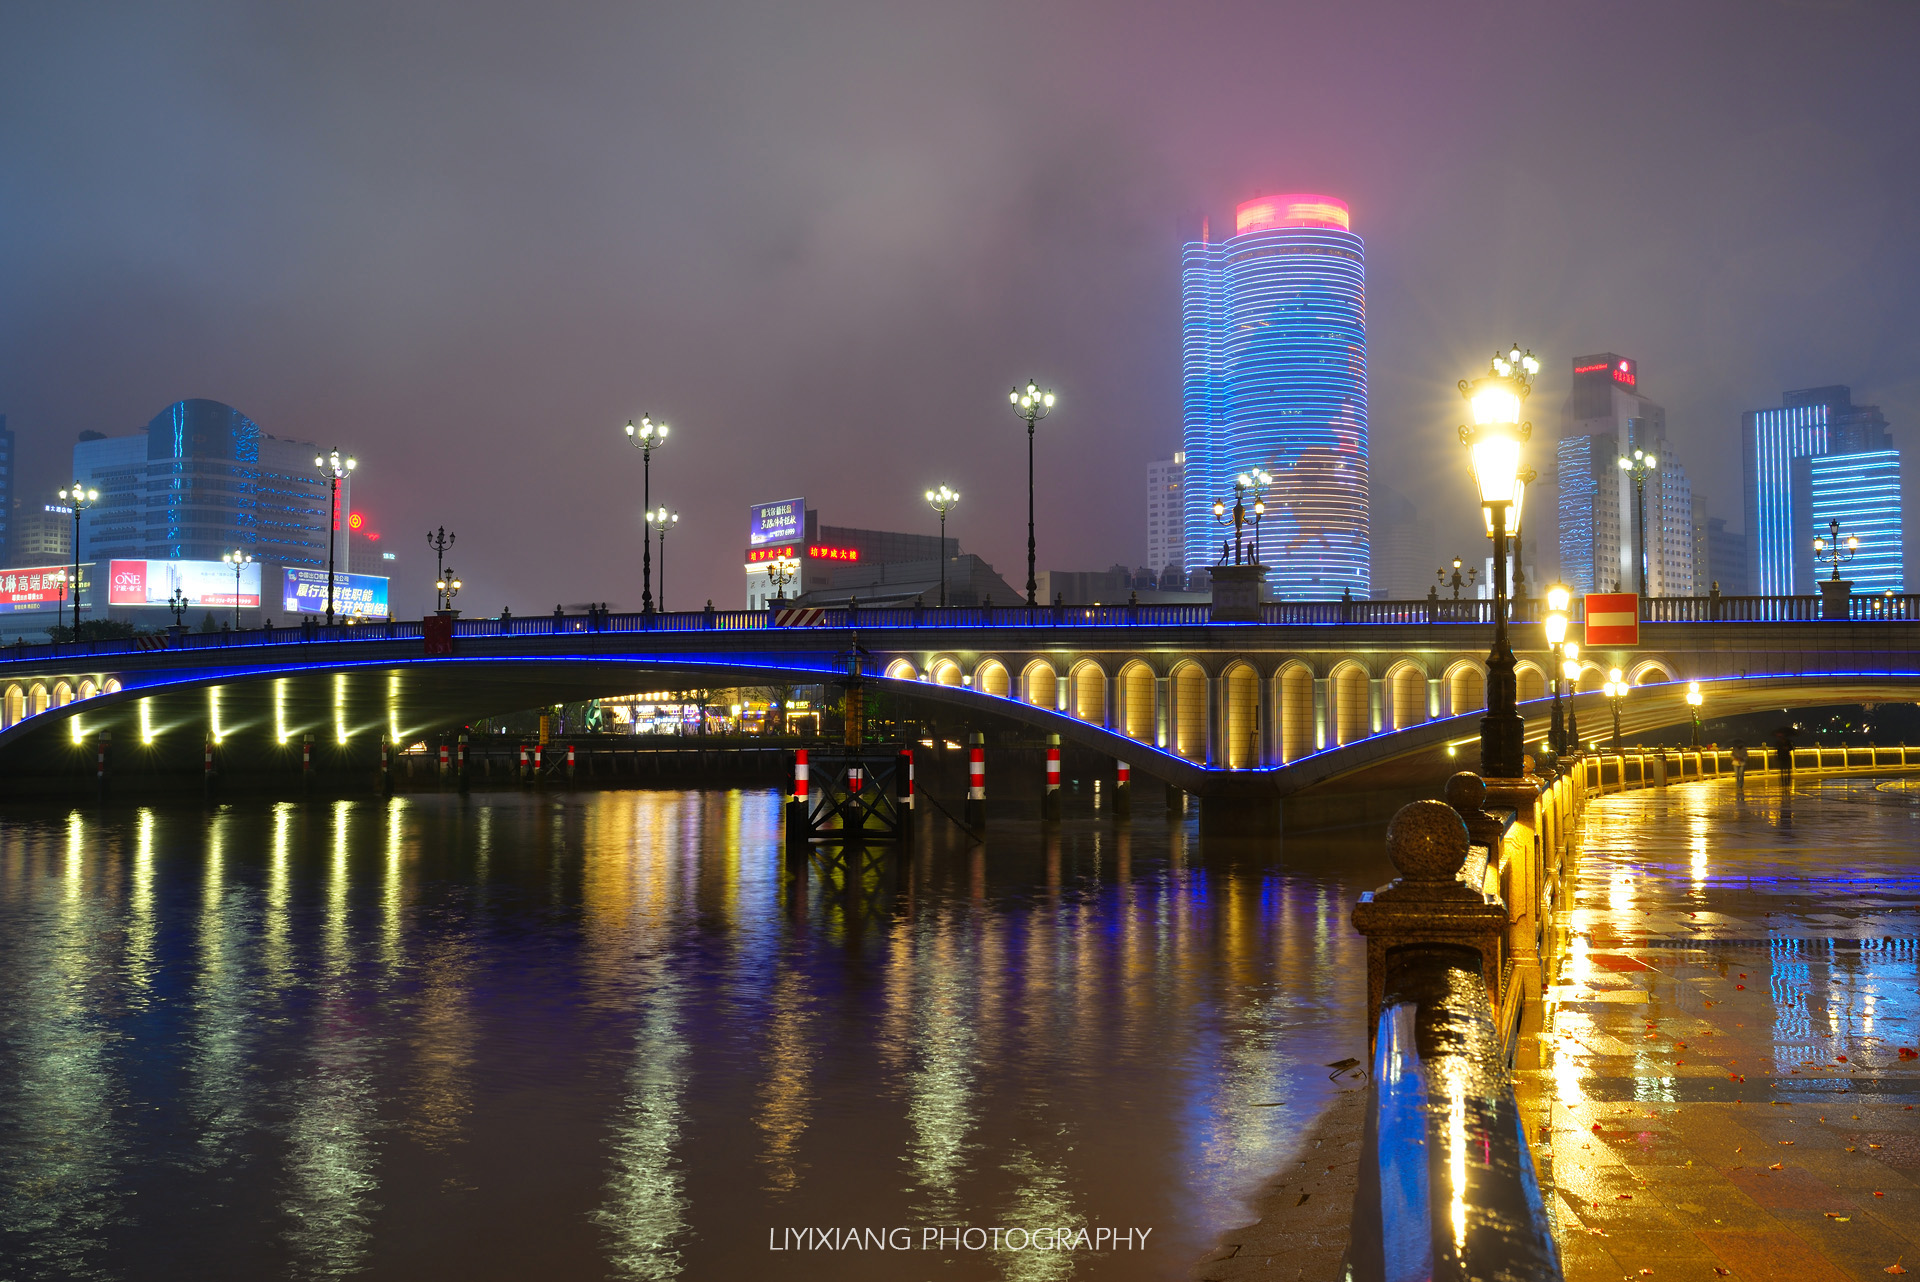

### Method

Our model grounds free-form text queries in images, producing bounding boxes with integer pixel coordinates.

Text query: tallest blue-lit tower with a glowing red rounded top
[1181,194,1371,599]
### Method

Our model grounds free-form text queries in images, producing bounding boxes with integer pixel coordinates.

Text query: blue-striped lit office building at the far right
[1740,384,1905,597]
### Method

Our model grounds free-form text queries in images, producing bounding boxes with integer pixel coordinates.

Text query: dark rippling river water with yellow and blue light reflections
[0,791,1390,1280]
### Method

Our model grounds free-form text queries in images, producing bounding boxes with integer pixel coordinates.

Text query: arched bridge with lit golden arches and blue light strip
[0,597,1920,796]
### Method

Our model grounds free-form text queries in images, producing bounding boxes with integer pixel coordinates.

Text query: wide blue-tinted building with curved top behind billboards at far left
[73,401,336,572]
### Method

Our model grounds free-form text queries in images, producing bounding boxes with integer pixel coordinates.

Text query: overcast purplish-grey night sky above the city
[0,0,1920,614]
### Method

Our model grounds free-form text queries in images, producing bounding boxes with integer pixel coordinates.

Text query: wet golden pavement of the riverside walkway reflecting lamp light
[1519,779,1920,1282]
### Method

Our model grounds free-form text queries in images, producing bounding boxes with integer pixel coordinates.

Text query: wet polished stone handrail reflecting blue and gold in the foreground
[1348,946,1561,1282]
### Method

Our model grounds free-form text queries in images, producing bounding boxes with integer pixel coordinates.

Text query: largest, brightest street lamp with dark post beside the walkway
[1459,345,1540,779]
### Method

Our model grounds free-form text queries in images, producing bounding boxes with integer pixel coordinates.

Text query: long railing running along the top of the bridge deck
[0,595,1920,662]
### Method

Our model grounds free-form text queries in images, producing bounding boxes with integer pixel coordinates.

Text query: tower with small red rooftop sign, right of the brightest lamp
[1555,351,1697,597]
